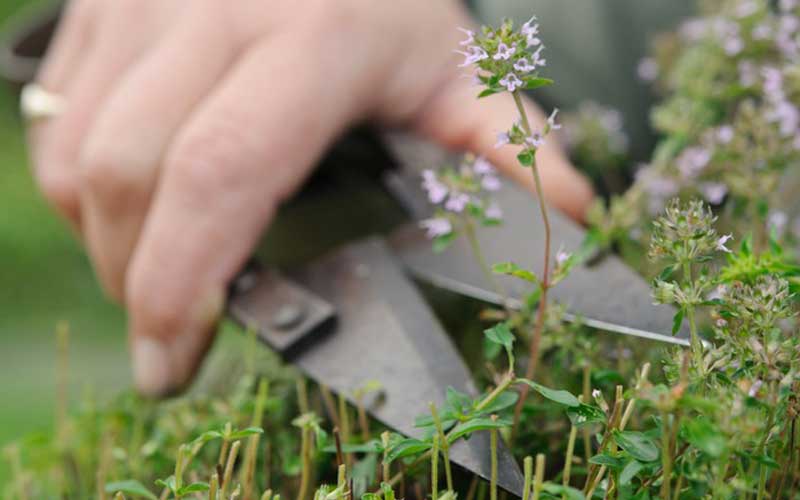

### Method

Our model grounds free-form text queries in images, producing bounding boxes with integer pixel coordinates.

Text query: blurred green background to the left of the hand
[0,0,129,478]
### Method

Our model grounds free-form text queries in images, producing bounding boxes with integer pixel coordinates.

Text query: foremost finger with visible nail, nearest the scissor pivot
[126,32,352,395]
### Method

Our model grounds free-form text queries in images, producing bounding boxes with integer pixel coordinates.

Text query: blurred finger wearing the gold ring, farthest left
[30,0,168,227]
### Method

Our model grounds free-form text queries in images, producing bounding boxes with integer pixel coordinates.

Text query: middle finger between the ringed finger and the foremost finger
[79,10,235,302]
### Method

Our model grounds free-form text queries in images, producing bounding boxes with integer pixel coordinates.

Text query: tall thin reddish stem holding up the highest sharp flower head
[511,91,551,442]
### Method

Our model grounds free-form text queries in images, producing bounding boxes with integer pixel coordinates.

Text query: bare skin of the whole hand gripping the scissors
[29,0,592,396]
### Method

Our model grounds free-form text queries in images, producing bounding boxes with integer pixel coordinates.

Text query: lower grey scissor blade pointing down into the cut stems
[229,238,523,495]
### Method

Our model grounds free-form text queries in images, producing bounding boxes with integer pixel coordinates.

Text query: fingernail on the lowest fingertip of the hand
[131,337,173,397]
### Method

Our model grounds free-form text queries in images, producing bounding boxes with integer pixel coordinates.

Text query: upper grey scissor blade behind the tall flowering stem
[387,132,689,346]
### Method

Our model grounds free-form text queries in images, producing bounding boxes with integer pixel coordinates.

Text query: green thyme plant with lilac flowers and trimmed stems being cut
[4,0,800,500]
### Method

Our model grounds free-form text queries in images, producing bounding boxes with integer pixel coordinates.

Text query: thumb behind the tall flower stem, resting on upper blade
[415,68,594,221]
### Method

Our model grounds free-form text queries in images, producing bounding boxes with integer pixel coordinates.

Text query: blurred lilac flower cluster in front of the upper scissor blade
[420,155,503,242]
